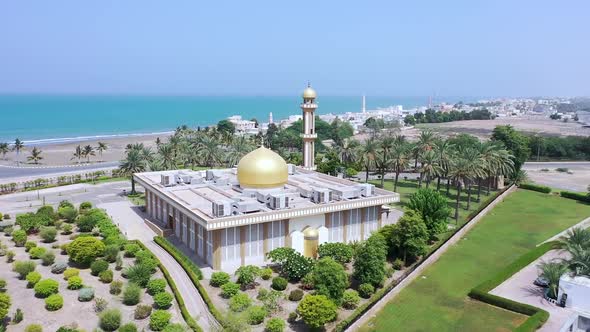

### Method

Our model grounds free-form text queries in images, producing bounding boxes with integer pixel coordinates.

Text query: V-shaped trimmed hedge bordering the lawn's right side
[468,241,559,332]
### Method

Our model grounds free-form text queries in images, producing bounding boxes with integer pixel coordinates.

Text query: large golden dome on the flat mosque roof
[238,147,289,188]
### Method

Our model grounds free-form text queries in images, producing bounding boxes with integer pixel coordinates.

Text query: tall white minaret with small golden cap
[301,84,318,171]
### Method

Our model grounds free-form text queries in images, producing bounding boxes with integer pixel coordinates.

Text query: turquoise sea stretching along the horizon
[0,95,467,144]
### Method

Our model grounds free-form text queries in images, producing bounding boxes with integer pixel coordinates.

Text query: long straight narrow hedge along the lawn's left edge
[333,185,512,332]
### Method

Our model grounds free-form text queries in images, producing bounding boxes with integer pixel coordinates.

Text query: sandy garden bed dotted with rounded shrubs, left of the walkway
[0,202,186,332]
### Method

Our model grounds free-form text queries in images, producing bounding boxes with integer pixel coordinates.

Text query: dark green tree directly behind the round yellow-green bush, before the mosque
[312,257,348,303]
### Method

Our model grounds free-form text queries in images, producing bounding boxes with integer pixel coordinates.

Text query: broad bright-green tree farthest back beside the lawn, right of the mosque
[407,188,449,239]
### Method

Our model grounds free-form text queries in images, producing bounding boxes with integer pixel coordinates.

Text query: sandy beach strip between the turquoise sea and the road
[0,133,170,166]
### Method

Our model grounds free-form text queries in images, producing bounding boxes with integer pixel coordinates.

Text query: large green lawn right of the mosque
[363,190,590,331]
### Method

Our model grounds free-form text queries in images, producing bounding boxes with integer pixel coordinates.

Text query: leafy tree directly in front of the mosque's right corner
[391,210,429,263]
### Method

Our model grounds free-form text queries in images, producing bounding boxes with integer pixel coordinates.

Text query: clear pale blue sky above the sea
[0,0,590,96]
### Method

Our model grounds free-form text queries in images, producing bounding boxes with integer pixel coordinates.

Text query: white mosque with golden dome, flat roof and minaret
[133,86,399,272]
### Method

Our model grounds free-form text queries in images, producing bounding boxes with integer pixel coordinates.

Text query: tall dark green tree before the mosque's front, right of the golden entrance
[352,233,387,286]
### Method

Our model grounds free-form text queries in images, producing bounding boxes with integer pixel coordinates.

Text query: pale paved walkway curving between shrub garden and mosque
[98,201,219,331]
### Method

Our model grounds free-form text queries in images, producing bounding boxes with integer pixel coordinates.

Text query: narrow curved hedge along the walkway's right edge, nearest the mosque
[154,236,225,326]
